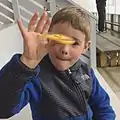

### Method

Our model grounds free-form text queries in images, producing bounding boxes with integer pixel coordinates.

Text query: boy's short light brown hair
[50,6,91,41]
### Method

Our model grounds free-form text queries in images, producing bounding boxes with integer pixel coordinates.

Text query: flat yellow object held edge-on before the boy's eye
[40,34,74,44]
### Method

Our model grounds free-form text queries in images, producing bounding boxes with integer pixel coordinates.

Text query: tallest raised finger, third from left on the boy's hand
[35,11,47,33]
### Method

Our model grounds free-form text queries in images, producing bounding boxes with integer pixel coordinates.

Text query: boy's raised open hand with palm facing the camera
[18,11,51,68]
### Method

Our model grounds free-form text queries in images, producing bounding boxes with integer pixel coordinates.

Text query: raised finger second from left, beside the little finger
[28,12,39,31]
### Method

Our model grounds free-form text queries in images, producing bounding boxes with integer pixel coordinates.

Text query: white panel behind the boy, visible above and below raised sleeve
[0,25,32,120]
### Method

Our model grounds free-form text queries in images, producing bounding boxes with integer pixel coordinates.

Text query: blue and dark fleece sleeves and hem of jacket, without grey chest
[0,55,115,120]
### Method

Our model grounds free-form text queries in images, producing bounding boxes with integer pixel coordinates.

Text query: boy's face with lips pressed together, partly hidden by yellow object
[48,22,89,71]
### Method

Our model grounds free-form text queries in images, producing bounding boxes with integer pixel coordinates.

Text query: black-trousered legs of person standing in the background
[96,0,106,33]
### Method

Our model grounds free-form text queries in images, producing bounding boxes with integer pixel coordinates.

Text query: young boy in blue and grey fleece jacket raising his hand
[0,6,115,120]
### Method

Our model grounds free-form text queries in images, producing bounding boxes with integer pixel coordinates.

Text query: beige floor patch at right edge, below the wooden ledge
[98,67,120,99]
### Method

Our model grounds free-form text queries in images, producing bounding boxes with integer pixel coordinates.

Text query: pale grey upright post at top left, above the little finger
[12,0,20,21]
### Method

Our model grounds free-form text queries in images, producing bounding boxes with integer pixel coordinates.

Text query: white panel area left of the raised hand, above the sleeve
[0,25,23,68]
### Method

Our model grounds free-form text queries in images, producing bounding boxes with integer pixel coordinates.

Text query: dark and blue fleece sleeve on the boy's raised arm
[0,54,40,118]
